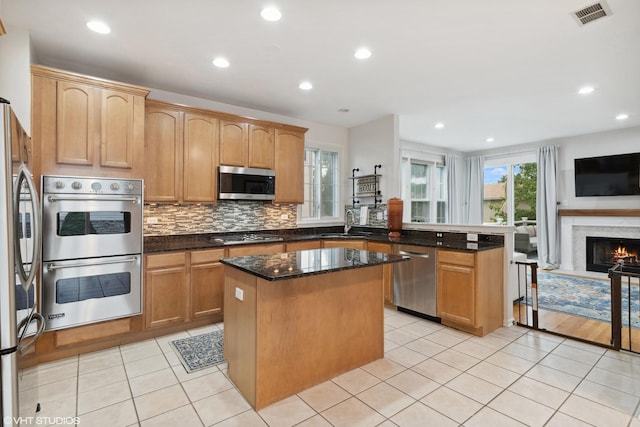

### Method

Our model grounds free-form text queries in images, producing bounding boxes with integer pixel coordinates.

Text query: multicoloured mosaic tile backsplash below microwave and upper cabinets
[144,200,298,236]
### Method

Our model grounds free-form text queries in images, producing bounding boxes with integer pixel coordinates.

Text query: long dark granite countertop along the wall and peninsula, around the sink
[144,227,504,254]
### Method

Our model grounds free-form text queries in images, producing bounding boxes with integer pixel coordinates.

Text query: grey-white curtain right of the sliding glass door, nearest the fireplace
[536,146,560,269]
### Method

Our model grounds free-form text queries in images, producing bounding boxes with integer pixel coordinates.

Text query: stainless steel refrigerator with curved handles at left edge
[0,98,44,426]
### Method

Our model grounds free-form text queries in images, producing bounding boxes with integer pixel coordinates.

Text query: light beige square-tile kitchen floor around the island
[21,309,640,427]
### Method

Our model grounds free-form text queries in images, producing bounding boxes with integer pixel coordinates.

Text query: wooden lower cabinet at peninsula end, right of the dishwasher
[437,248,504,336]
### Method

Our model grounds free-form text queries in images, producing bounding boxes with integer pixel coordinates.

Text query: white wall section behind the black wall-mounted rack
[345,115,400,204]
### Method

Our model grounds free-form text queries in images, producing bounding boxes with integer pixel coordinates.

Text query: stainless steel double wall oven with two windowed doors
[42,176,143,330]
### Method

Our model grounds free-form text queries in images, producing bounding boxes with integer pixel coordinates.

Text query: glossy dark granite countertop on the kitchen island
[220,248,409,281]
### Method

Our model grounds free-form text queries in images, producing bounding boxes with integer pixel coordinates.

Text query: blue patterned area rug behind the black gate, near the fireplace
[527,270,640,328]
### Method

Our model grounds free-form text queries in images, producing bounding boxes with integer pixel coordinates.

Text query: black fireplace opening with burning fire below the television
[586,236,640,273]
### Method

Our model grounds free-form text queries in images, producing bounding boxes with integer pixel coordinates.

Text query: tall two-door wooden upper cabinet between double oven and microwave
[144,100,219,203]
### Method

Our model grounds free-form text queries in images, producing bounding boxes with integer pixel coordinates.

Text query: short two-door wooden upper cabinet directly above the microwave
[220,119,275,169]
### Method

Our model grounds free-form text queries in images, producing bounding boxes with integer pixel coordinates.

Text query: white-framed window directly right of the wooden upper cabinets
[300,147,340,220]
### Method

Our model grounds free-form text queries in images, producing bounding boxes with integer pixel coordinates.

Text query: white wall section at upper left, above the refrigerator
[0,26,31,135]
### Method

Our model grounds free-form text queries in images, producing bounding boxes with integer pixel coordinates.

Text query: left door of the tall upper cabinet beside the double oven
[144,107,183,202]
